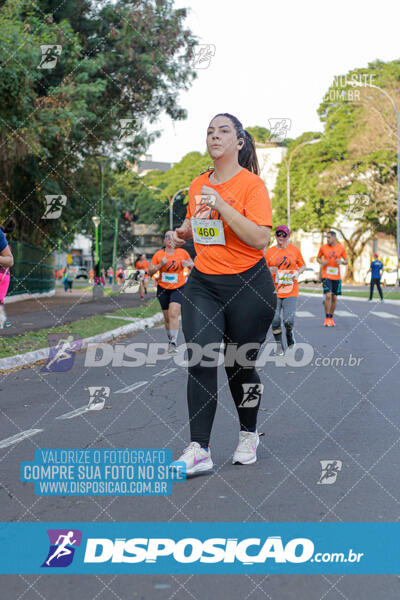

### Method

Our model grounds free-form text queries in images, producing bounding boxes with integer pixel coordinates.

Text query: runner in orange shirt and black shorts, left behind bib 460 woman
[148,231,193,353]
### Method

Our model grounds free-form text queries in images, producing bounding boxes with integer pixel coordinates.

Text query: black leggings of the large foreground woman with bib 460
[182,258,276,447]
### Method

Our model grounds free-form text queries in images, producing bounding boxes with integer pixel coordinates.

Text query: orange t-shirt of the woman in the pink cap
[265,244,306,298]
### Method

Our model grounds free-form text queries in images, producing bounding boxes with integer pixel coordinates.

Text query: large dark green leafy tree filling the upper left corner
[0,0,195,250]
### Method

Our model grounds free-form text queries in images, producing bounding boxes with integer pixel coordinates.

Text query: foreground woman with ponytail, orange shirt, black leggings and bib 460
[173,113,276,475]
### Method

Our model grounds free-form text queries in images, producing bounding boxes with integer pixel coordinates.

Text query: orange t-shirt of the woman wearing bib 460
[186,168,272,275]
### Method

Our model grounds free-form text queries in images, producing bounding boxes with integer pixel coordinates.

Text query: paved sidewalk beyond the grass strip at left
[0,287,155,337]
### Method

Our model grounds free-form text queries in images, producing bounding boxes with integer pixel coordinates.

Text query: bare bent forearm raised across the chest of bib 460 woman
[201,185,271,250]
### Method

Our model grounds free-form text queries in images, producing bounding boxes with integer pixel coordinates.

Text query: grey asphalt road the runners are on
[0,297,400,600]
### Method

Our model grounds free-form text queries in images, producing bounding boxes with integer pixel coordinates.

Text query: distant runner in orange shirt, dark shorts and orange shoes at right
[317,231,348,327]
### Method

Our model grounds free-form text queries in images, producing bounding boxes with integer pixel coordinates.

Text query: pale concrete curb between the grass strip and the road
[0,312,164,371]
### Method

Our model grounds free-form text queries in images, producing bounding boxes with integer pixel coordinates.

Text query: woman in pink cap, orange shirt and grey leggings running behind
[265,225,306,355]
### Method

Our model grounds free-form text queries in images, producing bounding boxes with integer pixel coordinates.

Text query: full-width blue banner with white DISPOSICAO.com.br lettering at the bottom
[0,522,400,575]
